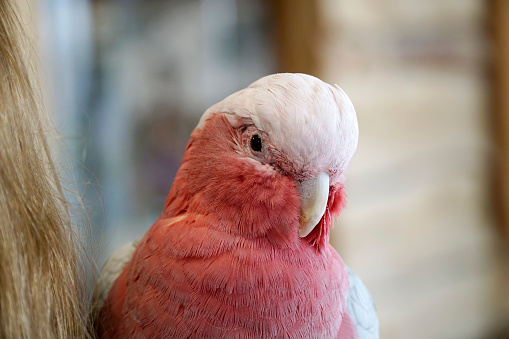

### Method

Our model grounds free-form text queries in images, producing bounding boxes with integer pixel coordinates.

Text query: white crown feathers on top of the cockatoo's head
[197,73,359,183]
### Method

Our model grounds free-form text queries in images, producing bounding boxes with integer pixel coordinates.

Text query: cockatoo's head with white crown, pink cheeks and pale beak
[166,74,358,248]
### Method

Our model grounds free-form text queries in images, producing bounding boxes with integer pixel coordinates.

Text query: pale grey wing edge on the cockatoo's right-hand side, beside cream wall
[346,267,379,339]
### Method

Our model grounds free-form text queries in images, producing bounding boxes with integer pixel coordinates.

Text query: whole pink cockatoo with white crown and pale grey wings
[95,74,378,338]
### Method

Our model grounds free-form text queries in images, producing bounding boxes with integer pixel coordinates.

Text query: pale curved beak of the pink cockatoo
[297,173,329,238]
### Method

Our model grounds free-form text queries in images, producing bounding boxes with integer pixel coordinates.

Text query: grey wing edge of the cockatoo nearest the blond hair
[89,240,140,326]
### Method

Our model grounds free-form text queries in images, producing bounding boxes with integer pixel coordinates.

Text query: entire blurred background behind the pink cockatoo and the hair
[15,0,509,339]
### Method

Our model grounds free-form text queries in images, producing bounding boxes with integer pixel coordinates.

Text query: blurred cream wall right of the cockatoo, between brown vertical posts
[316,0,506,339]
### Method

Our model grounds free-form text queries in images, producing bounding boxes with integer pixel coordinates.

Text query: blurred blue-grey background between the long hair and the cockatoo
[38,0,274,267]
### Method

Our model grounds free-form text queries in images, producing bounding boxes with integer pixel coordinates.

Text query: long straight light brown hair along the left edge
[0,0,88,338]
